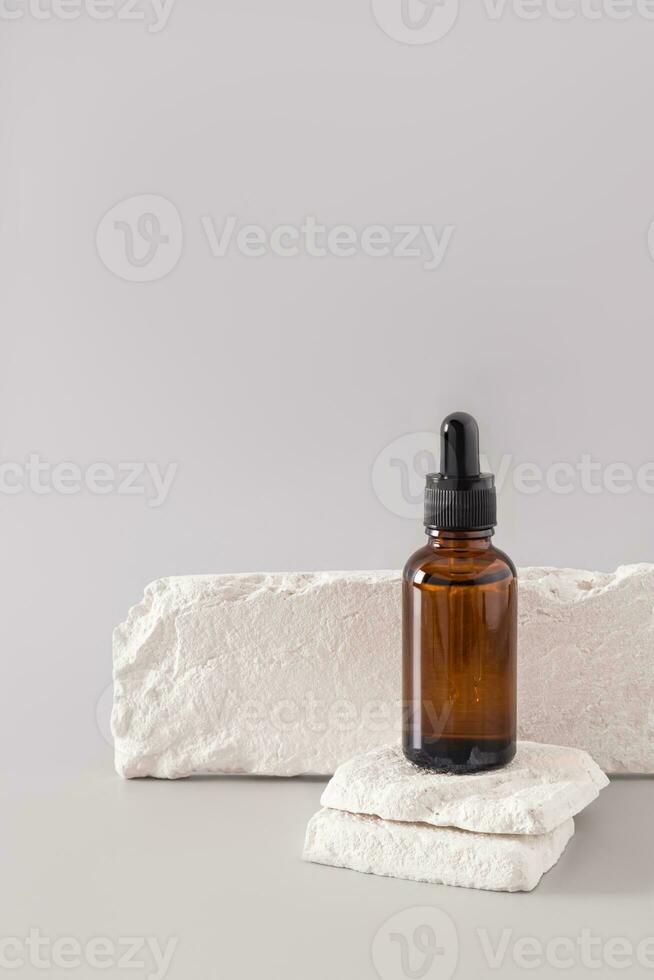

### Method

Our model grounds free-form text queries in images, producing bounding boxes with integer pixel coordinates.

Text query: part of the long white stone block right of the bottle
[518,564,654,773]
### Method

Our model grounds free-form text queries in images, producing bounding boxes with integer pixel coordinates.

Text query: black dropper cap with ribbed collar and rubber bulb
[425,412,497,531]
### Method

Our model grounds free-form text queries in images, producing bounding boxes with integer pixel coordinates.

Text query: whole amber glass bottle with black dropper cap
[403,412,517,773]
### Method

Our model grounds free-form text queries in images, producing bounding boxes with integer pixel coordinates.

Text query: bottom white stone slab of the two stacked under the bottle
[303,808,574,892]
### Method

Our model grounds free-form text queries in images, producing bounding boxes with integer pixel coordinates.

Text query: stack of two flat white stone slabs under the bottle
[304,742,608,891]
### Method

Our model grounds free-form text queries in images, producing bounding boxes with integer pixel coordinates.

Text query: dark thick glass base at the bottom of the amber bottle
[403,738,516,774]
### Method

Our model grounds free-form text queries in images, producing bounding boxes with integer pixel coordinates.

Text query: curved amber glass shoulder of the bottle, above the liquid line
[403,544,518,585]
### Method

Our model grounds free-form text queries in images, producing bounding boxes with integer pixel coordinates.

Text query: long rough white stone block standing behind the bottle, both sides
[112,565,654,778]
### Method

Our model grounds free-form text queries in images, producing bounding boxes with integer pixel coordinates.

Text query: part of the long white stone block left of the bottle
[112,572,400,778]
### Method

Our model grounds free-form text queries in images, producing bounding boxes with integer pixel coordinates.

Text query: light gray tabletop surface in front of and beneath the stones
[0,767,654,980]
